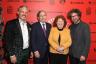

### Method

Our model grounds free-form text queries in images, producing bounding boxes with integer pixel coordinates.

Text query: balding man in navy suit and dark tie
[31,10,51,64]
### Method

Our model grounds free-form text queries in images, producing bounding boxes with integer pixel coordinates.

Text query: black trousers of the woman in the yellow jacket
[50,53,68,64]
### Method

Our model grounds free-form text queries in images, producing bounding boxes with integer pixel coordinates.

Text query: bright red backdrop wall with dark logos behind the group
[0,0,96,64]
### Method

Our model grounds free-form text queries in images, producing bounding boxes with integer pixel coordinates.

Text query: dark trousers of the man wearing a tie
[34,54,49,64]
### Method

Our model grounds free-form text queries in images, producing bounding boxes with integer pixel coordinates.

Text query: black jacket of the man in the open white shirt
[3,19,30,56]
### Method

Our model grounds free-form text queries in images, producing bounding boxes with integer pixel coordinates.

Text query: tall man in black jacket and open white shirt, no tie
[4,6,30,64]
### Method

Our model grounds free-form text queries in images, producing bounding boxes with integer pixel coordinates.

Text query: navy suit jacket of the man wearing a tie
[31,22,51,57]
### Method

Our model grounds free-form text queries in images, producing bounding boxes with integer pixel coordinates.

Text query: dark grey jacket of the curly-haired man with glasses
[69,21,90,58]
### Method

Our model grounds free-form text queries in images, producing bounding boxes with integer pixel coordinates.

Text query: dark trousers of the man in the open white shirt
[8,49,29,64]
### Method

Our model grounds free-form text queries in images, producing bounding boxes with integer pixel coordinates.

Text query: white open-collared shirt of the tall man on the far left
[19,19,29,49]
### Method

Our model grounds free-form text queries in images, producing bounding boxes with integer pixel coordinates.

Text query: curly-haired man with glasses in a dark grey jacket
[68,9,90,64]
